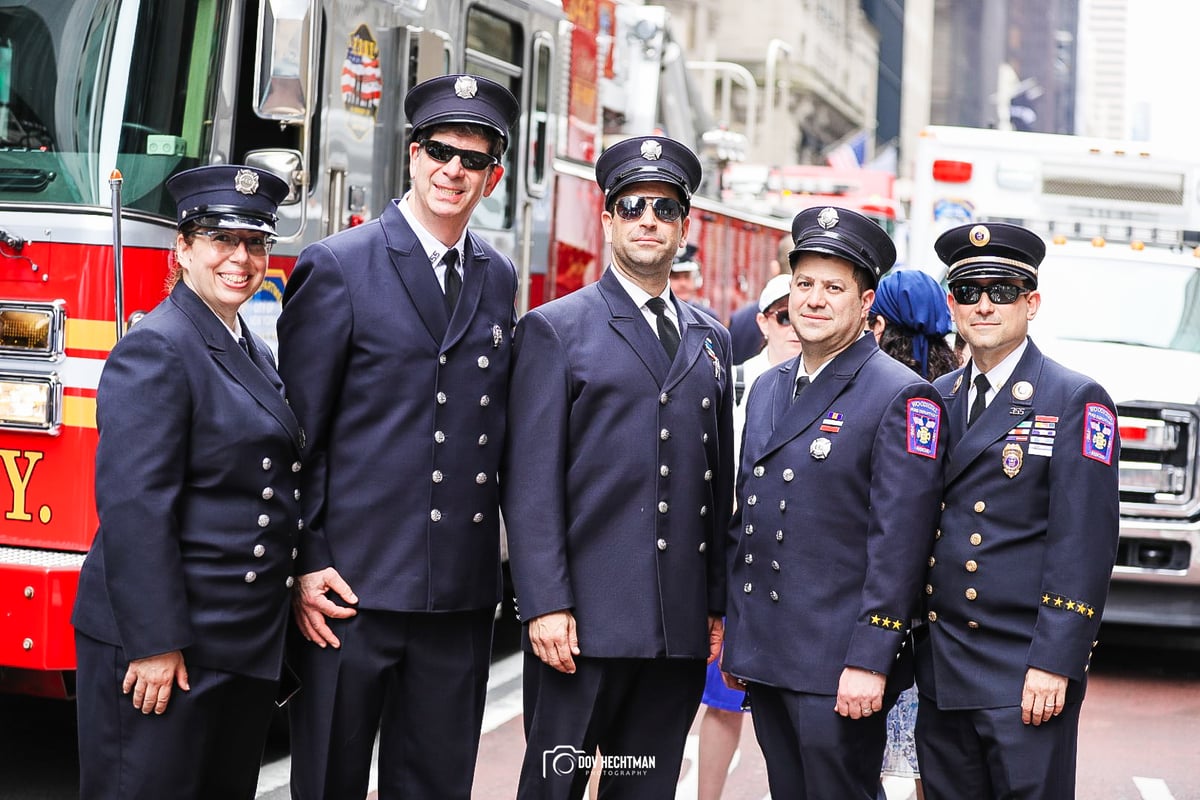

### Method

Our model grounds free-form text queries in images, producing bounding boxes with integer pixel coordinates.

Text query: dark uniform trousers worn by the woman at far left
[76,633,277,800]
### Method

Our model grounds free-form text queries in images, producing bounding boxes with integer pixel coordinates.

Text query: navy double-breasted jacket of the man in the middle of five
[504,267,733,658]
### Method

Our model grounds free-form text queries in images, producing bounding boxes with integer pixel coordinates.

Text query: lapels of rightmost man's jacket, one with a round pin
[946,341,1043,483]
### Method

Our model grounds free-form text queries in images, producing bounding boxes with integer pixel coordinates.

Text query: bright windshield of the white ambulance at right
[1031,251,1200,353]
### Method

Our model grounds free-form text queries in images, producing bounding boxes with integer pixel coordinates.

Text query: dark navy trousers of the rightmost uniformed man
[917,696,1080,800]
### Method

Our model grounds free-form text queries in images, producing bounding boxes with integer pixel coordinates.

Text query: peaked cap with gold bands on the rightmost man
[934,222,1046,289]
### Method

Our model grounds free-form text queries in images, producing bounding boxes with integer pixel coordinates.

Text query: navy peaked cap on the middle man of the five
[596,136,703,209]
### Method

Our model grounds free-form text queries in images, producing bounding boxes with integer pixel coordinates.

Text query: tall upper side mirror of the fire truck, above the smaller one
[254,0,313,125]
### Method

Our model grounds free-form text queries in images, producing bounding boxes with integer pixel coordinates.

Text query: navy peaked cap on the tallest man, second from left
[404,76,520,146]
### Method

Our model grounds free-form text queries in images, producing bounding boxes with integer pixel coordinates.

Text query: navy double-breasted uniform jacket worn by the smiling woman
[73,282,304,680]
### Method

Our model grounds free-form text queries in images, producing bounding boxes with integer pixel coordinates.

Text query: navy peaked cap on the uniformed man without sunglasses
[787,206,896,289]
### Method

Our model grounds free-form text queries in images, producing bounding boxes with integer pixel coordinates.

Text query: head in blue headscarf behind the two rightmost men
[866,270,959,380]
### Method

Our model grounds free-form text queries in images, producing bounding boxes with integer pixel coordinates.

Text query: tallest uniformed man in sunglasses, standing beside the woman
[278,76,518,800]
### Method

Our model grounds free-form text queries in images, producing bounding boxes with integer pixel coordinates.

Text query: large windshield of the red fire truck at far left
[0,0,226,216]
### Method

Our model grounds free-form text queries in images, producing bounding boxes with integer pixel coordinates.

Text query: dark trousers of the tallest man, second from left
[288,608,496,800]
